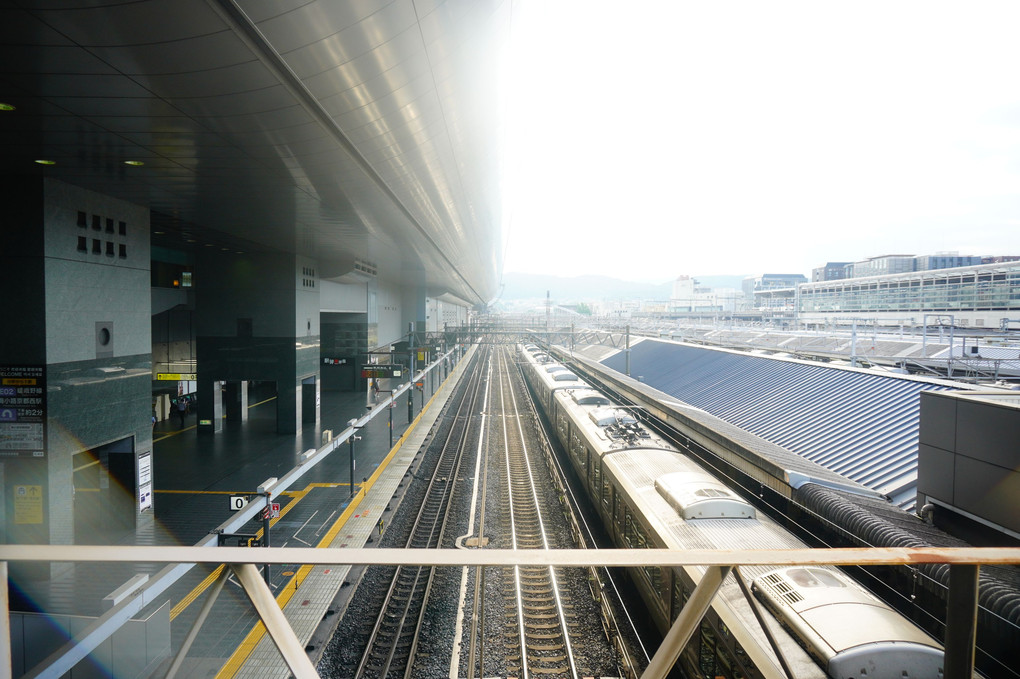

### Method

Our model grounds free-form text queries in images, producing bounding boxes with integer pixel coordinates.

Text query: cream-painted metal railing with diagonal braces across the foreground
[0,544,1020,679]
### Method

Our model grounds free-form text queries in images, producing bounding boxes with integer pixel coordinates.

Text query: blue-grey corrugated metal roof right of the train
[603,340,955,510]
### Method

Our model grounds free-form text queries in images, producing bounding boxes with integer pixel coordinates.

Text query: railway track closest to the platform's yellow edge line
[354,348,485,679]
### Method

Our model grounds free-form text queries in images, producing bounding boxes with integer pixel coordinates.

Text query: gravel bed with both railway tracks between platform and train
[322,347,622,679]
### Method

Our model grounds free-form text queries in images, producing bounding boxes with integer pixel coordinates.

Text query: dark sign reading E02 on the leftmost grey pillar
[0,365,46,458]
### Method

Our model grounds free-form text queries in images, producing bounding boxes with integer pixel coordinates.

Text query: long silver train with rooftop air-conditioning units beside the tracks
[518,345,945,679]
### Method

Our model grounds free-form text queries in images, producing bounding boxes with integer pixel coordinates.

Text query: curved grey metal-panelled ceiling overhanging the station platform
[0,0,510,303]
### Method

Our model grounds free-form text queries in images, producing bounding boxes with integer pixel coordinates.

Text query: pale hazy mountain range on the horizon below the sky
[499,273,744,304]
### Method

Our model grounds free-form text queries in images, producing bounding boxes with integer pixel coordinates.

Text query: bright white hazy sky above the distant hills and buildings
[505,0,1020,282]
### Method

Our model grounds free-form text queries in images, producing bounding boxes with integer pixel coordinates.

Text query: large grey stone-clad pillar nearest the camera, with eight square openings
[0,176,152,558]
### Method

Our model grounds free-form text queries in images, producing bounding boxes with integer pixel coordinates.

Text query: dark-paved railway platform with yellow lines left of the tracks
[12,348,469,679]
